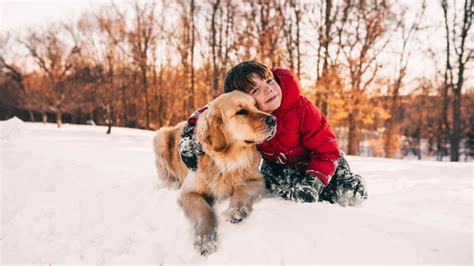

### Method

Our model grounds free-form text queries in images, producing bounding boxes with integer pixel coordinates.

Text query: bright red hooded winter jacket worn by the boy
[258,69,339,185]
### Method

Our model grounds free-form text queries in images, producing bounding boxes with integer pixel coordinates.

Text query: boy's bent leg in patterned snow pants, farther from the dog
[319,154,368,206]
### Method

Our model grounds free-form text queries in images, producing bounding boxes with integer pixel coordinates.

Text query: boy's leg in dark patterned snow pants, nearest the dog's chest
[260,160,318,202]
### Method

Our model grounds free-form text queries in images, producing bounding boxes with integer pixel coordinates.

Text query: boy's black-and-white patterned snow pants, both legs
[260,154,367,206]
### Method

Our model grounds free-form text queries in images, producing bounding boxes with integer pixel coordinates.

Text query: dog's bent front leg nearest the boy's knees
[224,178,264,223]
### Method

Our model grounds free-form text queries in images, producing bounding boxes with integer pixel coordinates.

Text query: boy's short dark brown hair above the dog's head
[224,61,273,93]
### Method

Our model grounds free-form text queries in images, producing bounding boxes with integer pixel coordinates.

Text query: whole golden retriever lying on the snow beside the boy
[154,91,276,255]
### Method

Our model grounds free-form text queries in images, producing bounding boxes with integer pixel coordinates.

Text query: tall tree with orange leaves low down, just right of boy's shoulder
[340,1,391,155]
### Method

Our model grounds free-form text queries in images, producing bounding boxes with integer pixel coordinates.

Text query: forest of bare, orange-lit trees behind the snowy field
[0,0,474,161]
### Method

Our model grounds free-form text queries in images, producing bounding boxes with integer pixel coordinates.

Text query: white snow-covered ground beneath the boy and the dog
[0,120,474,265]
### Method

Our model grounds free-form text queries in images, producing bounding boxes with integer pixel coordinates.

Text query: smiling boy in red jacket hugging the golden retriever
[180,61,367,206]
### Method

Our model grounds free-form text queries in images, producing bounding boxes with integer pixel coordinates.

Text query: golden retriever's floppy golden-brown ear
[197,108,228,152]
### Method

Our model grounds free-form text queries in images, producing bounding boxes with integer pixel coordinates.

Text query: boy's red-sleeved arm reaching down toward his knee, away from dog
[300,101,340,185]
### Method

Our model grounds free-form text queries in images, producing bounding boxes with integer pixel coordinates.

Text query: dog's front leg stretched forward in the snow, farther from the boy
[180,192,217,256]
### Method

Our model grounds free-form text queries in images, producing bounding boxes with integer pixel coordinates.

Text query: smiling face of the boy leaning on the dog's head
[248,75,281,114]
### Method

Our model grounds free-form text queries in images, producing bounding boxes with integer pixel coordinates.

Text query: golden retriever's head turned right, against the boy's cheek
[196,91,276,152]
